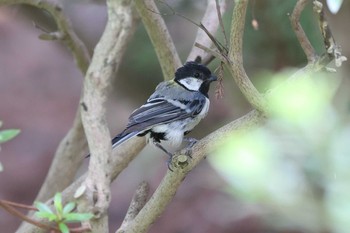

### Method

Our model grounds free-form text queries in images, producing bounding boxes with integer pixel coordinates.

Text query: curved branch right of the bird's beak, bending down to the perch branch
[228,0,267,112]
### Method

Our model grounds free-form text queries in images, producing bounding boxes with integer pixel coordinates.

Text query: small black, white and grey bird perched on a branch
[112,61,217,170]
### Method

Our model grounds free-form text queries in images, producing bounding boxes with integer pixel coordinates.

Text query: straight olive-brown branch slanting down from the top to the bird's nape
[135,0,182,80]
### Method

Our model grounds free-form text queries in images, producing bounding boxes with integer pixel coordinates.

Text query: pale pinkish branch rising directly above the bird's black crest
[187,0,227,64]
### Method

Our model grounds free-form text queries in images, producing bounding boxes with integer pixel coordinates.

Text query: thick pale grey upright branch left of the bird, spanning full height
[81,0,135,232]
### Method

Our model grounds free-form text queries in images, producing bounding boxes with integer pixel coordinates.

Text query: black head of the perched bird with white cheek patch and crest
[175,61,217,96]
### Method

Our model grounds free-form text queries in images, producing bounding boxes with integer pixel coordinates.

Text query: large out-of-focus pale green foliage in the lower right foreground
[209,72,350,233]
